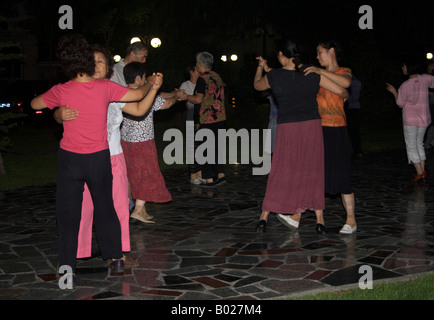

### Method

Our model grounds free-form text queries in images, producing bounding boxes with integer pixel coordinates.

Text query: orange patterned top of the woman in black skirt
[316,67,351,127]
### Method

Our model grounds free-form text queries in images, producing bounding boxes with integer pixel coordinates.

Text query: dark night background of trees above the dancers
[0,0,434,129]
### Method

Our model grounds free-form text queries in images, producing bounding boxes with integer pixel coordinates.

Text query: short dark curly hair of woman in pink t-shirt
[57,34,95,80]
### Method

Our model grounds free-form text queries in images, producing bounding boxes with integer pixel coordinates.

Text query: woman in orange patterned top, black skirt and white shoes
[305,41,357,234]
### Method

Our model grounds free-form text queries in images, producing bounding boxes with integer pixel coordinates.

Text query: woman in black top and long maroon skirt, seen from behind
[254,39,348,232]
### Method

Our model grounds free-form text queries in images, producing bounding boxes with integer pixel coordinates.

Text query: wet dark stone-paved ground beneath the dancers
[0,150,434,300]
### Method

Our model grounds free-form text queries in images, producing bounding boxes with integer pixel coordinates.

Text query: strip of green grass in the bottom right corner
[291,273,434,300]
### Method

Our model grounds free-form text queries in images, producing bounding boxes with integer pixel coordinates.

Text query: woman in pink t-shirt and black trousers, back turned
[31,35,159,280]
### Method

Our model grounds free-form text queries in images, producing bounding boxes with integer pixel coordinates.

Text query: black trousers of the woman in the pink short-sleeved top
[56,149,122,270]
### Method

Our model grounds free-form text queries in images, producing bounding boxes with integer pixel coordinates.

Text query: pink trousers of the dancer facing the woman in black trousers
[77,153,131,258]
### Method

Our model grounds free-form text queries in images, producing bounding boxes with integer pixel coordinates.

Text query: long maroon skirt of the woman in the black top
[262,120,325,214]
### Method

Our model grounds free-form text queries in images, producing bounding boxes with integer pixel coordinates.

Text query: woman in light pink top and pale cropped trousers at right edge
[386,63,434,181]
